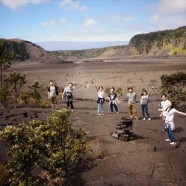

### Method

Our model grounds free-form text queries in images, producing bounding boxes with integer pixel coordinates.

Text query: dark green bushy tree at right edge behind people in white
[161,72,186,105]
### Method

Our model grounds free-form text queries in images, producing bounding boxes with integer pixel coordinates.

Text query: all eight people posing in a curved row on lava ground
[48,80,186,145]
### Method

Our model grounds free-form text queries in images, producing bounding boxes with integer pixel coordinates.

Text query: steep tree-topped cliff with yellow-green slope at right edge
[129,26,186,56]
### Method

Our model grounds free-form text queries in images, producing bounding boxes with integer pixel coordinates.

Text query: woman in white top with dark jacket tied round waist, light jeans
[95,86,105,115]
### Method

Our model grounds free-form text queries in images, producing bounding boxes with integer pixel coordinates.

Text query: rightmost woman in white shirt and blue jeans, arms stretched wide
[159,102,186,145]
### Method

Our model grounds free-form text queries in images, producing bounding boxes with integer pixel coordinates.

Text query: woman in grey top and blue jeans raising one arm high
[140,86,154,121]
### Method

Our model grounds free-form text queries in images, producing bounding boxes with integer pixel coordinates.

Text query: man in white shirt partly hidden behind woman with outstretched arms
[160,94,171,131]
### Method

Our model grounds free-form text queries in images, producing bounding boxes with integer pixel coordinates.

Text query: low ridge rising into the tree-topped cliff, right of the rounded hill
[55,26,186,61]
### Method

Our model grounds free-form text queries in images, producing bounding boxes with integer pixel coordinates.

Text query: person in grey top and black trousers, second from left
[62,83,75,111]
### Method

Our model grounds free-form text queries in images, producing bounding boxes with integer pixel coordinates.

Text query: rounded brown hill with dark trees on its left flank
[0,39,59,63]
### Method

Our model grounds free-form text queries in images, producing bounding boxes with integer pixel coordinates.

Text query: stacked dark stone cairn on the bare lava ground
[112,117,134,141]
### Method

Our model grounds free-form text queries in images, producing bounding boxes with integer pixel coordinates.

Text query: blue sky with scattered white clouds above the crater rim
[0,0,186,42]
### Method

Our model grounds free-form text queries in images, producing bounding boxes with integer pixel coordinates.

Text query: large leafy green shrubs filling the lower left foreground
[0,109,87,186]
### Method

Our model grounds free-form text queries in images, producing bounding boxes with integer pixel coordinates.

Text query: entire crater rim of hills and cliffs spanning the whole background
[0,26,186,63]
